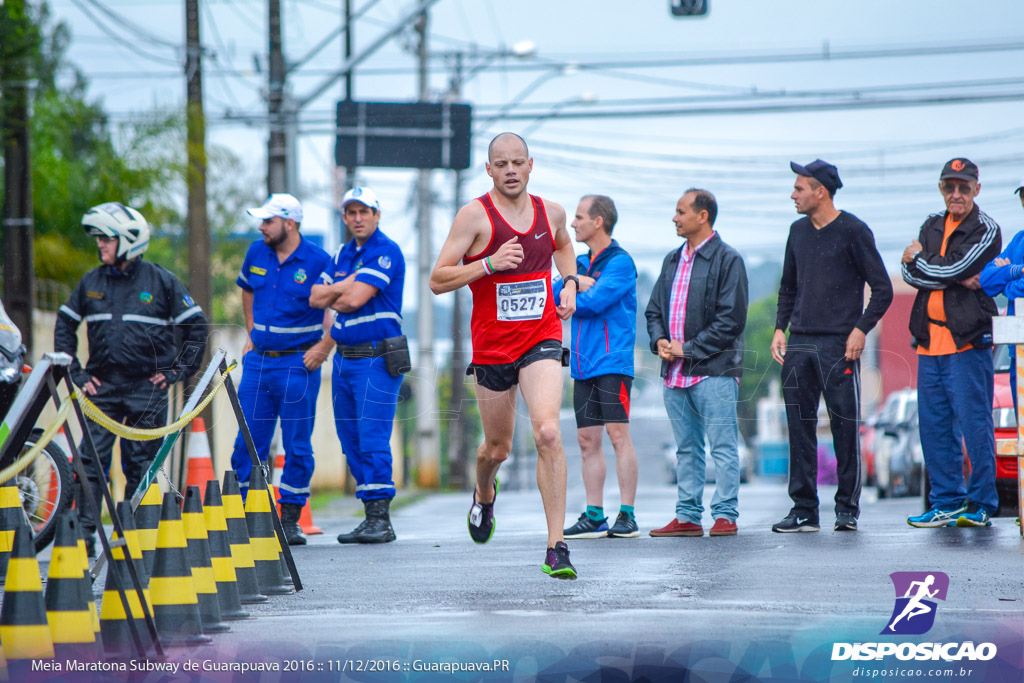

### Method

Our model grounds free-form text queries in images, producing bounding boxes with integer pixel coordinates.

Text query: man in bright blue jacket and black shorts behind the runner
[552,195,640,539]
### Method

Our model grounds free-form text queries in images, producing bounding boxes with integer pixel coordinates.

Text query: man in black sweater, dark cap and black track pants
[771,159,893,532]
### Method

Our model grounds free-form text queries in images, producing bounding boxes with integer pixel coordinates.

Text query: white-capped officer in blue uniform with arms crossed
[309,187,409,543]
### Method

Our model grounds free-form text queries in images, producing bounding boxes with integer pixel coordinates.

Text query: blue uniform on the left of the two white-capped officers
[231,240,331,506]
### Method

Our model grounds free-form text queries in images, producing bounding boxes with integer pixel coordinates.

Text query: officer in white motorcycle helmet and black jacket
[53,202,207,557]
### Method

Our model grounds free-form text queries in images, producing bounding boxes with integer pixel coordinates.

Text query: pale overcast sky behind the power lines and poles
[51,0,1024,294]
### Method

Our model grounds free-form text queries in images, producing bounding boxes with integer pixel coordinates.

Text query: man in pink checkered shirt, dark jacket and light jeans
[646,188,748,537]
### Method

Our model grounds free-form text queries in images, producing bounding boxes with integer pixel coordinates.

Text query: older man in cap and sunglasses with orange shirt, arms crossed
[902,158,999,527]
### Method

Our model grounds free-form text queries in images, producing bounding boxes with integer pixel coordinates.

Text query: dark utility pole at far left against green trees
[0,0,36,349]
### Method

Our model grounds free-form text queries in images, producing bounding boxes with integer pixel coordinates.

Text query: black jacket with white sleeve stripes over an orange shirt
[901,205,1002,348]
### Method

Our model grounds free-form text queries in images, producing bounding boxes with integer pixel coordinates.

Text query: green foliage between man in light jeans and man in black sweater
[736,294,781,441]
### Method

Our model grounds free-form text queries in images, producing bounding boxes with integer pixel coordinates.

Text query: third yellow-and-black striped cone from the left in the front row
[99,501,153,657]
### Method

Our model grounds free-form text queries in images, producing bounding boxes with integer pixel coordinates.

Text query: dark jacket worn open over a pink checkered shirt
[645,232,748,377]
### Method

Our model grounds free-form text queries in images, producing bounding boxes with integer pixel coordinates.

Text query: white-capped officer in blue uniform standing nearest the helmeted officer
[231,195,333,546]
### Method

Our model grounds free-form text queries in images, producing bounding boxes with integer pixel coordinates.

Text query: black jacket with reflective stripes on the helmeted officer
[53,258,207,385]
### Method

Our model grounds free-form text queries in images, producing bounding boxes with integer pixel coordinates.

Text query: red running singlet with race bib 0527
[463,195,562,365]
